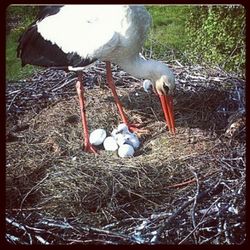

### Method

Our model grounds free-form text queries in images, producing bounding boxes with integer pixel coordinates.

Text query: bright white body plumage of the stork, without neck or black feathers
[36,5,151,68]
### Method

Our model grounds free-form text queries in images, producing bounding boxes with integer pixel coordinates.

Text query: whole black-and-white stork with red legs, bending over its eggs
[17,5,175,153]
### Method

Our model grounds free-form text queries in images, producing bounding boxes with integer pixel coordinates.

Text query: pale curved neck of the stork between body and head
[118,55,158,80]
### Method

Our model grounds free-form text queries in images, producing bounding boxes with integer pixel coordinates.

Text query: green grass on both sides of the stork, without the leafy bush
[6,5,188,80]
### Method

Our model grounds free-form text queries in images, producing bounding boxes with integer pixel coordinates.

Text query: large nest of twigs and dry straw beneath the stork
[6,61,246,244]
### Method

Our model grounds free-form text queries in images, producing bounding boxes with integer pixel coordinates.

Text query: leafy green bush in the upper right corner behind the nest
[186,5,246,75]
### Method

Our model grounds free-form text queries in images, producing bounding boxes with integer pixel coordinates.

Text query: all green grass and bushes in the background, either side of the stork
[6,5,246,80]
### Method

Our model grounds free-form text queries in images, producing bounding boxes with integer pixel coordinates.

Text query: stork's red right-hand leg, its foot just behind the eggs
[106,62,147,133]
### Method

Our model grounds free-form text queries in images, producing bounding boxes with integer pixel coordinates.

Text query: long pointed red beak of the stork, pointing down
[158,93,175,134]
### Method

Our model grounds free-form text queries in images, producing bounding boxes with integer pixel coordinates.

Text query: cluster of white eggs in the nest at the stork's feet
[89,123,140,157]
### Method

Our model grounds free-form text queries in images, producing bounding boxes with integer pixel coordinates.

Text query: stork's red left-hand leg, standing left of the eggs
[76,73,97,153]
